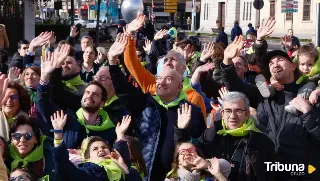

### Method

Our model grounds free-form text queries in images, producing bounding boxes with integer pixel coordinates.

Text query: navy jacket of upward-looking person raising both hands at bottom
[50,141,142,181]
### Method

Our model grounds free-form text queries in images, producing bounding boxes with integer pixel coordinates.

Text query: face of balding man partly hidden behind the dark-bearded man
[94,69,115,98]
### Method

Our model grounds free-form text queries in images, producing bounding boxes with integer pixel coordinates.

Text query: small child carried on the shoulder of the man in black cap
[256,43,320,116]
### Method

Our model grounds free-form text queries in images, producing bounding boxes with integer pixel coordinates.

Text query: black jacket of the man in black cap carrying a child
[221,63,320,181]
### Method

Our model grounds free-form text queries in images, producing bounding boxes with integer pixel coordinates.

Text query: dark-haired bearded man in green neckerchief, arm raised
[37,47,116,149]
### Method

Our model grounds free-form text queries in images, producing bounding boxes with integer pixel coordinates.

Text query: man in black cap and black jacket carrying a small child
[221,19,320,181]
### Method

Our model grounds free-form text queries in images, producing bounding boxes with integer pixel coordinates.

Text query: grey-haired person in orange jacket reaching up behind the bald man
[119,14,206,118]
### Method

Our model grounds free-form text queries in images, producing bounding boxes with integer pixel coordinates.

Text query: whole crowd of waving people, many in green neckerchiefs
[0,14,320,181]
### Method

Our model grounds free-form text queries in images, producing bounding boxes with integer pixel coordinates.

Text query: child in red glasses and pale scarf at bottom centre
[165,142,231,181]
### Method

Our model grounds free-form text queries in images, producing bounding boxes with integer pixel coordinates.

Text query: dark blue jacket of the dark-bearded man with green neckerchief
[37,84,116,149]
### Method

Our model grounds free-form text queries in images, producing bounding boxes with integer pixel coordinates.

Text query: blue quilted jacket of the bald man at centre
[110,65,206,180]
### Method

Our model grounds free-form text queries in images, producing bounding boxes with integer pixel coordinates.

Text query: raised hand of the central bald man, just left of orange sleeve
[108,33,128,65]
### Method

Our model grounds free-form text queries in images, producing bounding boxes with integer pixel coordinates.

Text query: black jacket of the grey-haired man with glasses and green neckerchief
[175,120,275,181]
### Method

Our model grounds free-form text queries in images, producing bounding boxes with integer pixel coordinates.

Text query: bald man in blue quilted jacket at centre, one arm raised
[109,35,206,181]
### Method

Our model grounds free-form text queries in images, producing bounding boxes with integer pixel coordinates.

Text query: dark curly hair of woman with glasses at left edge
[8,82,31,113]
